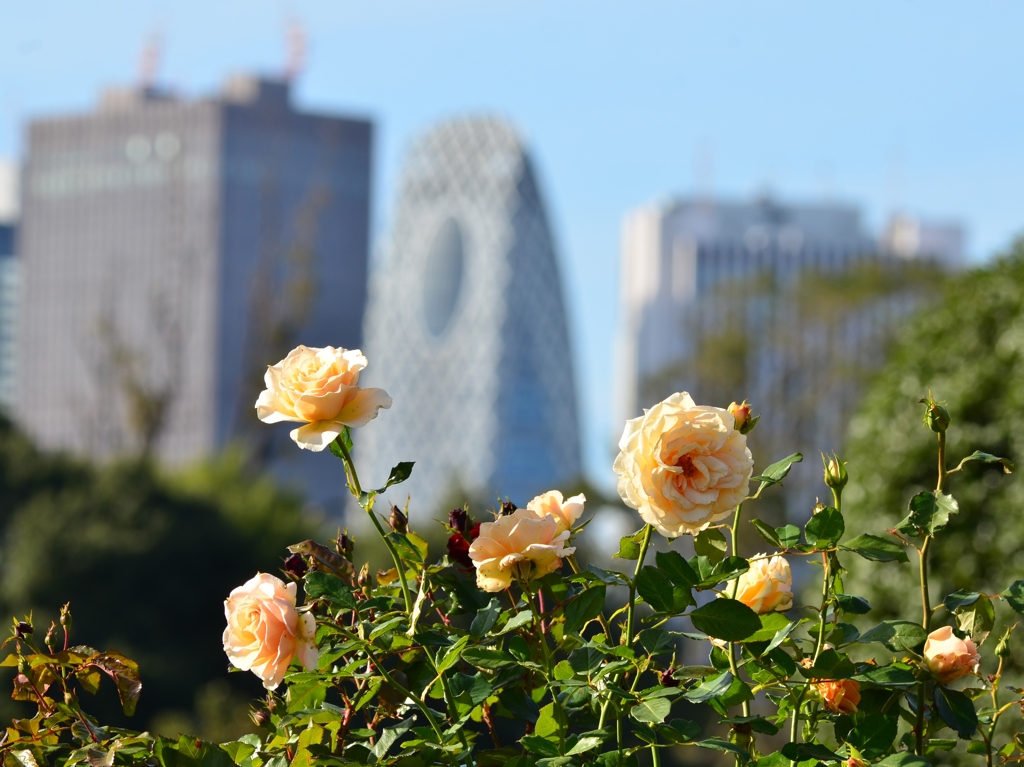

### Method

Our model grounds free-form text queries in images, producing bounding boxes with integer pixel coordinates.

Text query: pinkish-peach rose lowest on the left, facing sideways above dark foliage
[223,572,319,690]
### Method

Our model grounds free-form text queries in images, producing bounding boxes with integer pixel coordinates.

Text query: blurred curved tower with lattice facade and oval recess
[355,118,580,512]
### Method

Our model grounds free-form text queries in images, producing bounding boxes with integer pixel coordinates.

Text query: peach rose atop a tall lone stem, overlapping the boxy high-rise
[256,346,391,452]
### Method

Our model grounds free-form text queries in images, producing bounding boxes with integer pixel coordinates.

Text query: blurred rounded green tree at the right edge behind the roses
[843,240,1024,634]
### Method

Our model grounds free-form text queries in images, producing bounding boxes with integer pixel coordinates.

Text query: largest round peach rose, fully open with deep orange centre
[613,392,754,538]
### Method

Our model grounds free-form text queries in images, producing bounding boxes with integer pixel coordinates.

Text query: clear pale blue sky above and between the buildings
[0,0,1024,483]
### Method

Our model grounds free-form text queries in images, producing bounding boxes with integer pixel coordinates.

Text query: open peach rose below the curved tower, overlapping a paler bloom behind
[469,509,575,592]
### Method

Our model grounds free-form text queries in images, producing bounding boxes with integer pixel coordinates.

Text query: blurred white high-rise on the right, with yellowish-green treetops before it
[615,199,937,513]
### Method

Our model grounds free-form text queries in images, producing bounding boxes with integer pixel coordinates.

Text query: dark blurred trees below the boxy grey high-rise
[0,416,314,739]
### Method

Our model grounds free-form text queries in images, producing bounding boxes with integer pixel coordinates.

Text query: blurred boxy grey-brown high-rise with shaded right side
[15,76,372,473]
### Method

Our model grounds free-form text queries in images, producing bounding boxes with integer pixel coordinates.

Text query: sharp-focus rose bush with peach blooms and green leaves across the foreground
[0,358,1024,767]
